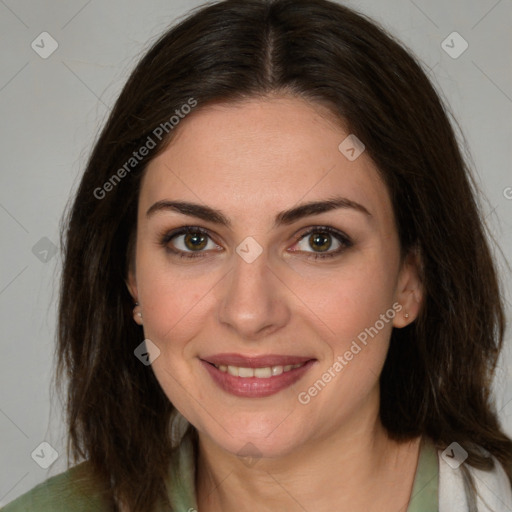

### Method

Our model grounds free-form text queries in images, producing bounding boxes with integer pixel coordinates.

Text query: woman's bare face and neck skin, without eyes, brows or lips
[128,96,422,512]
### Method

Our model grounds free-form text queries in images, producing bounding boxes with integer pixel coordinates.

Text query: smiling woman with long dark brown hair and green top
[5,0,512,512]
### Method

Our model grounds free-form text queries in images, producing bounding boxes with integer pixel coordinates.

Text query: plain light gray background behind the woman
[0,0,512,506]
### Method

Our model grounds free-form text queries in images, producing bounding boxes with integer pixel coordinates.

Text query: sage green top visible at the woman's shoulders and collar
[2,437,439,512]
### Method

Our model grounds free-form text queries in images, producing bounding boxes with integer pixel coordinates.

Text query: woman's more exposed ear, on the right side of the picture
[393,248,424,328]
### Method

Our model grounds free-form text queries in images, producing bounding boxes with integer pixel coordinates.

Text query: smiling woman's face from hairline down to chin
[129,97,419,457]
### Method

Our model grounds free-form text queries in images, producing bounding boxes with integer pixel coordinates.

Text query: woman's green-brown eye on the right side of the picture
[290,226,353,259]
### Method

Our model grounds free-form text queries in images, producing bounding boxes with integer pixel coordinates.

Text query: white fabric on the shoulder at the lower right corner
[438,451,512,512]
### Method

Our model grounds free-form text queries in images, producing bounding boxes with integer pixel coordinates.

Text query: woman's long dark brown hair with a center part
[57,0,512,512]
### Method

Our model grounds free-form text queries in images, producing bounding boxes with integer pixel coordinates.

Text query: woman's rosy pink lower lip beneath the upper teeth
[201,359,315,398]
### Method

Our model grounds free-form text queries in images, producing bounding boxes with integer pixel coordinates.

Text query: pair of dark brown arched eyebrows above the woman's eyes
[146,197,372,227]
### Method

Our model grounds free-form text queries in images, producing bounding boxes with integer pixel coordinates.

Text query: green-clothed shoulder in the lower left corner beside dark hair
[1,462,108,512]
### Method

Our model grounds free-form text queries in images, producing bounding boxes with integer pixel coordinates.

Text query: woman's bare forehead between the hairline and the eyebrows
[140,97,391,228]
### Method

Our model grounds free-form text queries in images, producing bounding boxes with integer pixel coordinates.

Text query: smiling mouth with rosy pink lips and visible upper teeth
[200,354,316,398]
